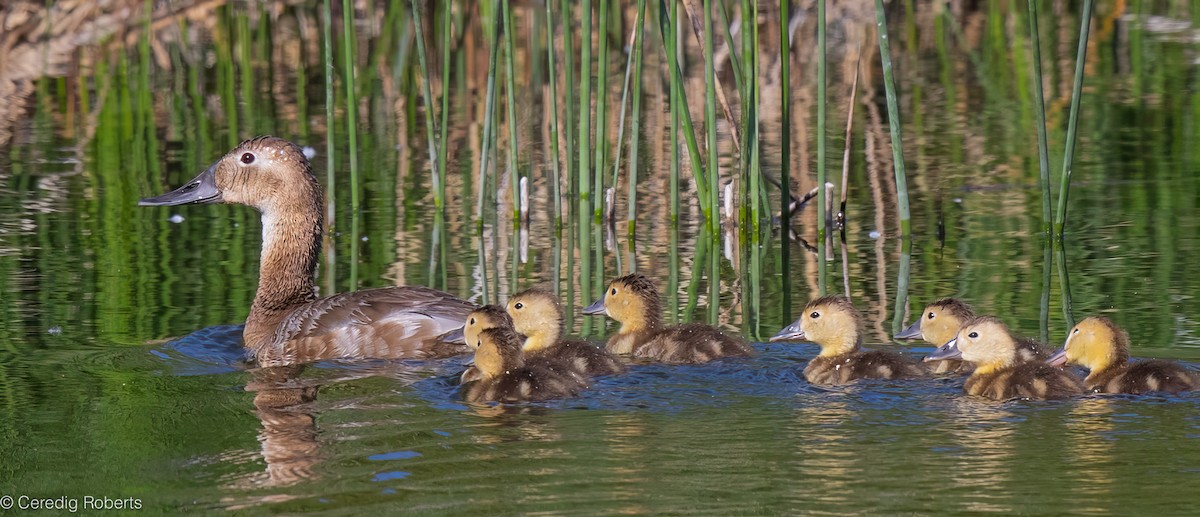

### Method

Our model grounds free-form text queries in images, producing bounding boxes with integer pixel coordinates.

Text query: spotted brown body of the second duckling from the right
[962,362,1084,401]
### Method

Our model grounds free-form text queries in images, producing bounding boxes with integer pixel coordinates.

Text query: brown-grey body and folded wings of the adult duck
[255,285,475,366]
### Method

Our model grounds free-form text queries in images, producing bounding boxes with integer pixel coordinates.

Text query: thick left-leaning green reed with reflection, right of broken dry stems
[878,0,912,333]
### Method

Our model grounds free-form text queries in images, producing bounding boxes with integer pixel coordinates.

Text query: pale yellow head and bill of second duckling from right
[925,315,1016,374]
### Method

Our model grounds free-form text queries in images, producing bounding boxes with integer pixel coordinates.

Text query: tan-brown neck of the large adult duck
[251,203,322,319]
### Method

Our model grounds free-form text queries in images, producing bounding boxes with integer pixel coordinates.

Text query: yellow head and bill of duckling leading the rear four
[770,295,862,356]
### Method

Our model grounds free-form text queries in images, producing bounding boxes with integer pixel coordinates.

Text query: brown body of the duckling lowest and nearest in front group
[463,365,587,403]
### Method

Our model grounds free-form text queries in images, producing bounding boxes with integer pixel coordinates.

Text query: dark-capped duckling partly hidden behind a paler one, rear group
[894,297,1050,373]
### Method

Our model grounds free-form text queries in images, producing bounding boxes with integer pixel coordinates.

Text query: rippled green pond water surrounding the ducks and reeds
[0,1,1200,515]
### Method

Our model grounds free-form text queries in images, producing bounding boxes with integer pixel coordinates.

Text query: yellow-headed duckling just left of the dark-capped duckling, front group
[508,289,625,377]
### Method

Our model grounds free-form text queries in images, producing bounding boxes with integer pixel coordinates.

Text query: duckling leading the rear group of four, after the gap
[770,295,925,385]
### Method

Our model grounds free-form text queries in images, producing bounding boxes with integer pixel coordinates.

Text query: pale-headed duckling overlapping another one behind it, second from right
[925,315,1084,401]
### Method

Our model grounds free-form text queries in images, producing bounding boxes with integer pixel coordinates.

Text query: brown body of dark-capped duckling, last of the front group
[634,323,754,365]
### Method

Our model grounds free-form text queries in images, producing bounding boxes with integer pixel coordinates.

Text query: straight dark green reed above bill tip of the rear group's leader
[779,0,792,320]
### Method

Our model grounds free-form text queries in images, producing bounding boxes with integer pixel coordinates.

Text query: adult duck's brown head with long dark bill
[138,137,320,214]
